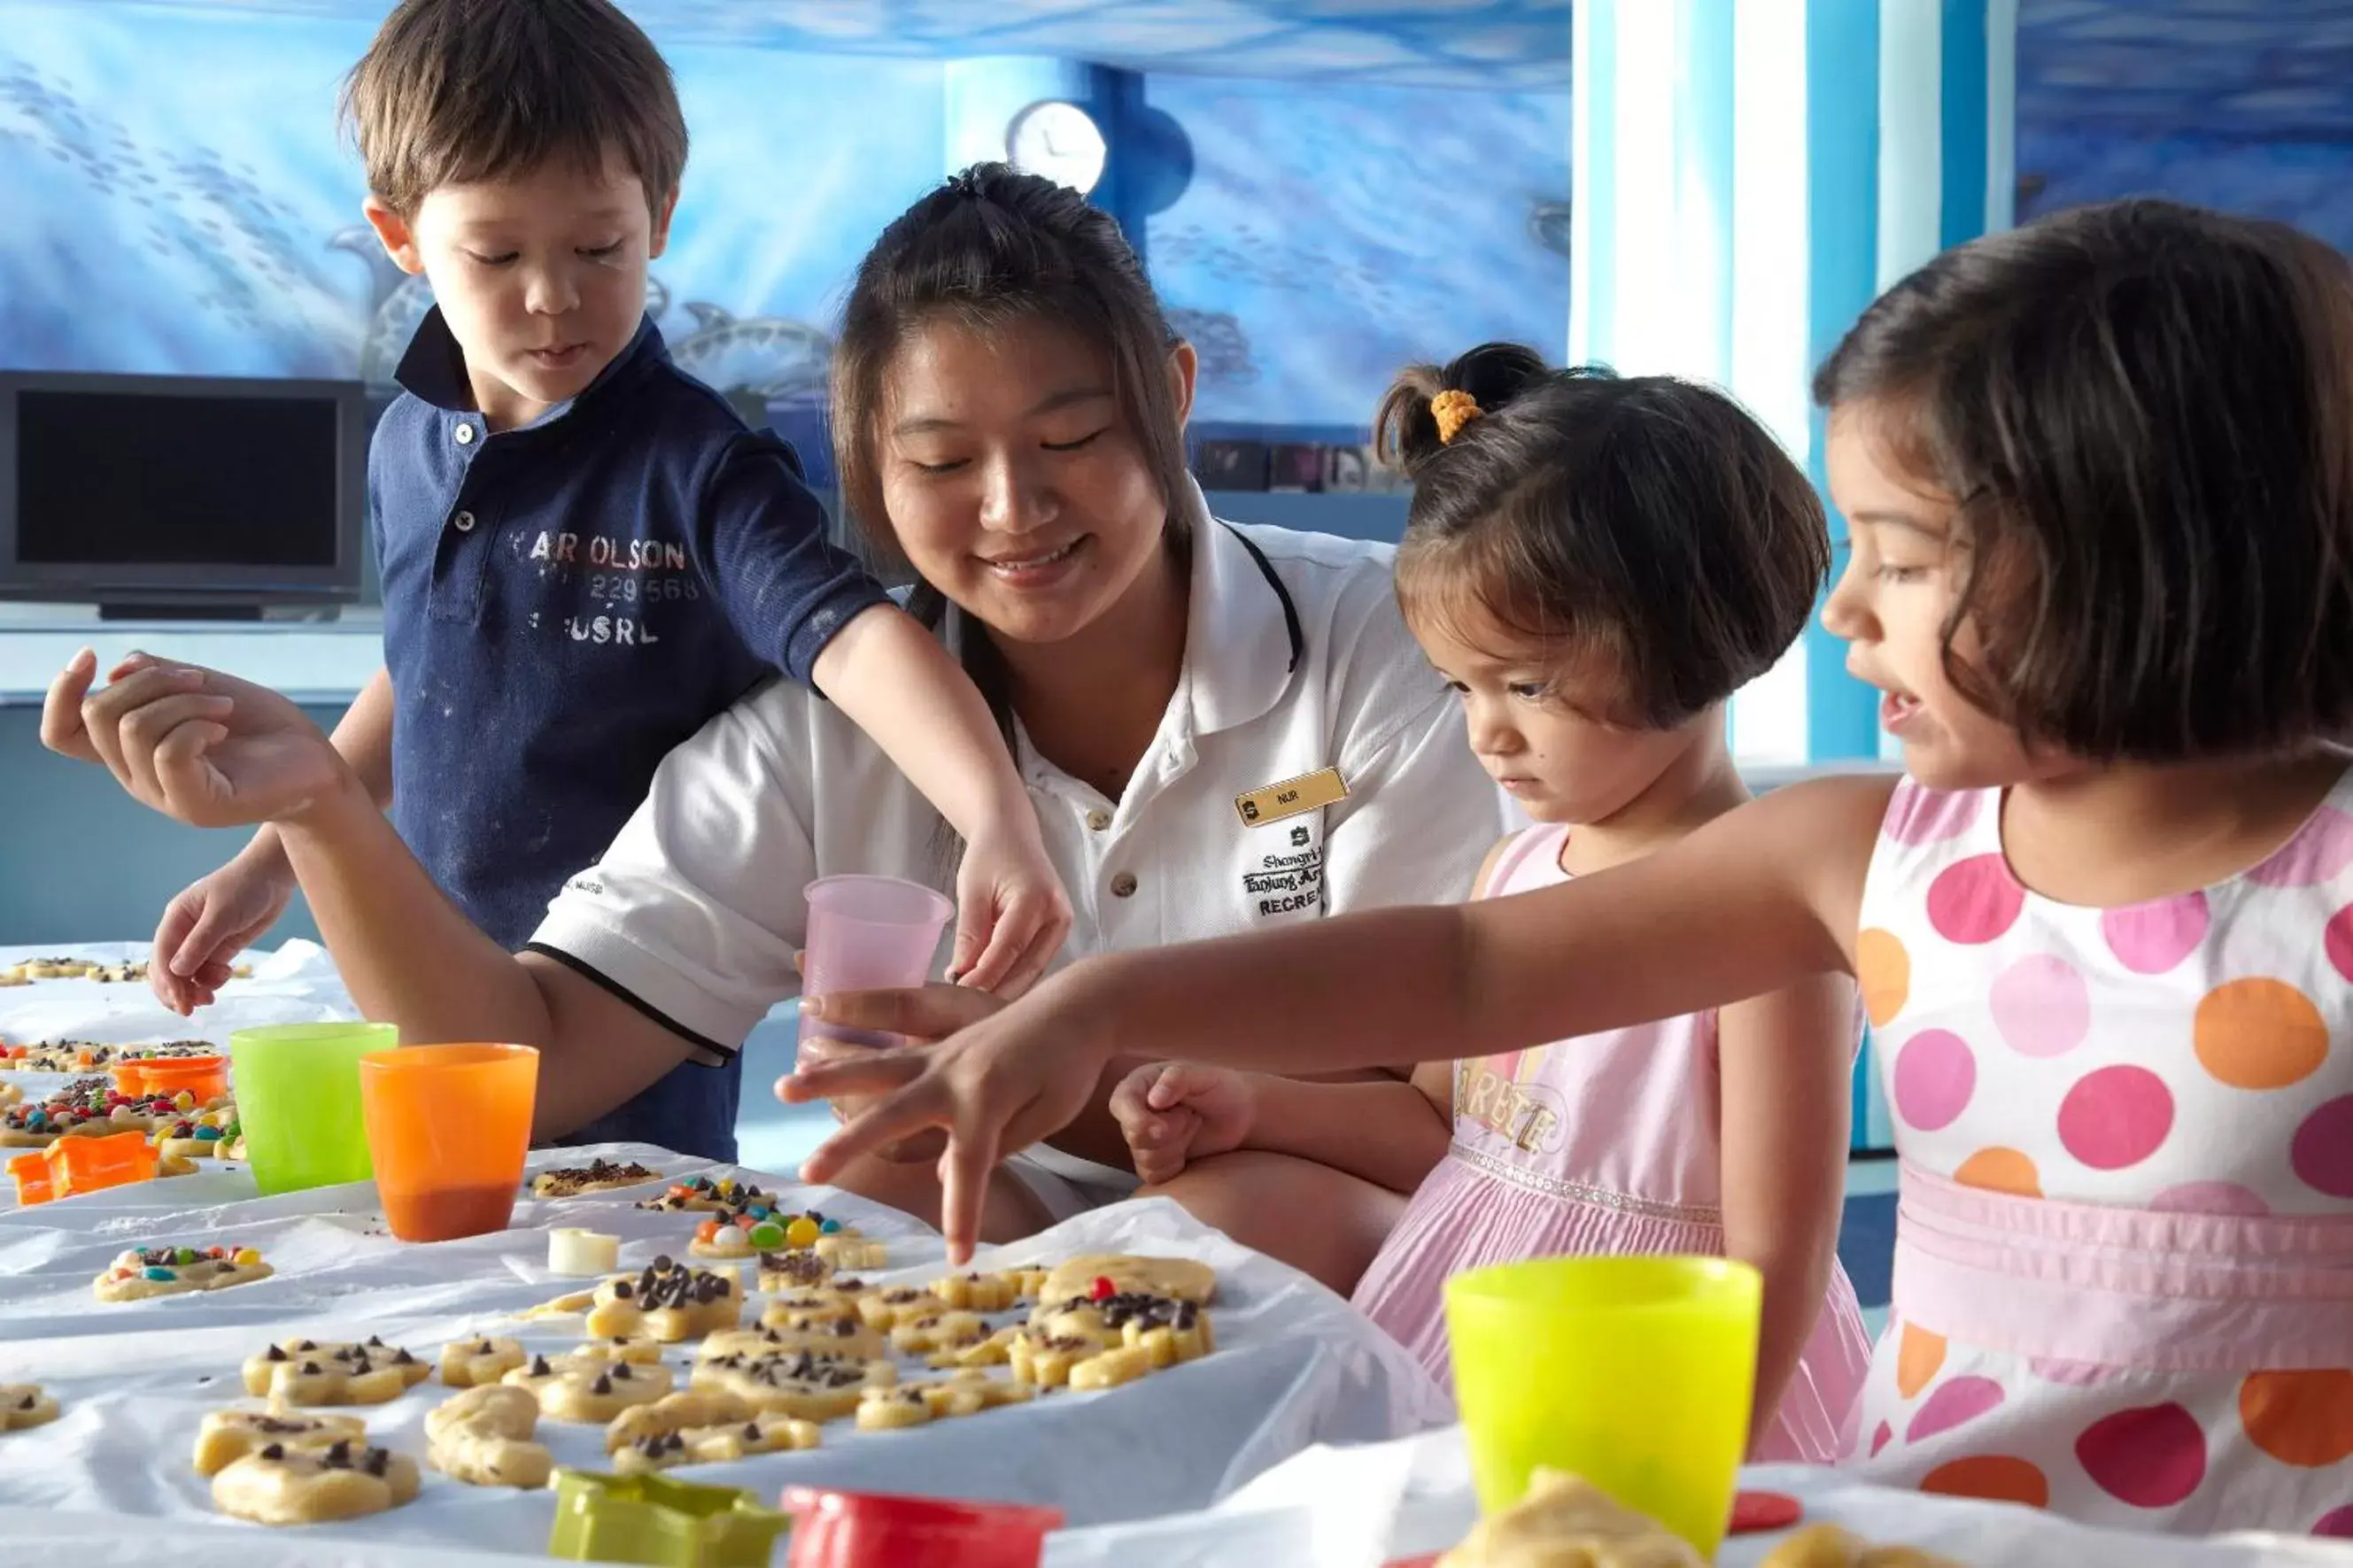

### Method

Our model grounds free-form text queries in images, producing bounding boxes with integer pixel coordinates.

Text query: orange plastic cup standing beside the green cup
[360,1047,538,1241]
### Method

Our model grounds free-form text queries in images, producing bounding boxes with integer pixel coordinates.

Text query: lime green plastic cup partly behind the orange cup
[228,1023,400,1192]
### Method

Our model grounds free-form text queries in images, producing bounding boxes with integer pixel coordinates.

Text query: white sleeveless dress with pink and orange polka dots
[1847,774,2353,1535]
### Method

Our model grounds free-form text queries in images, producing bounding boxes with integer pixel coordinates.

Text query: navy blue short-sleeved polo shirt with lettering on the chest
[367,310,887,1159]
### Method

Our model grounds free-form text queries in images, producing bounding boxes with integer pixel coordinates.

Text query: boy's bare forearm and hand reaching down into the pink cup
[812,604,1071,997]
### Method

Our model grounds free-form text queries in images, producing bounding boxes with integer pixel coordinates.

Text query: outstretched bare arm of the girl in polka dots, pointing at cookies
[788,778,1892,1258]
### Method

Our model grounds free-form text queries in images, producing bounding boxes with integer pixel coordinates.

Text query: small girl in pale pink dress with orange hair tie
[1113,345,1870,1463]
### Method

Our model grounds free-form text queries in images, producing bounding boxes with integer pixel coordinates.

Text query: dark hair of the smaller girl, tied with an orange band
[1374,344,1831,729]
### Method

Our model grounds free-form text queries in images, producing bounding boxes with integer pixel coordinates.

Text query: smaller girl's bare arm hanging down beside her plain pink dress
[1718,976,1856,1441]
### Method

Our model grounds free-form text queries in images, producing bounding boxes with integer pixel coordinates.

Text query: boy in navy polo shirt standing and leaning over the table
[137,0,1068,1159]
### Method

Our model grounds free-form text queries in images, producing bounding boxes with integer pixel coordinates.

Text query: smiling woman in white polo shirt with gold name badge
[51,165,1505,1288]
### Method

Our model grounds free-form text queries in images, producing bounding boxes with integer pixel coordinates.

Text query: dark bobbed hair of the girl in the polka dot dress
[1815,200,2353,764]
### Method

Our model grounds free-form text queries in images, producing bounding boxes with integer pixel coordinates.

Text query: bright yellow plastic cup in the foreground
[1447,1258,1762,1561]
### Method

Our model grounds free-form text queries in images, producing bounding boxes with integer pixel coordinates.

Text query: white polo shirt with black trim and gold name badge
[531,489,1515,1180]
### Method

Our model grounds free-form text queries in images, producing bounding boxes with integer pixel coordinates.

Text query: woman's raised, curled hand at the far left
[40,649,351,828]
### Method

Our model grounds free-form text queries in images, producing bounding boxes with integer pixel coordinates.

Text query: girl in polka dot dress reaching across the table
[786,202,2353,1535]
